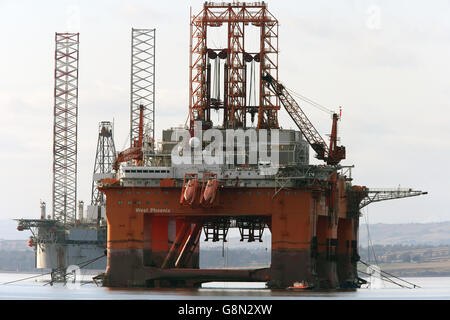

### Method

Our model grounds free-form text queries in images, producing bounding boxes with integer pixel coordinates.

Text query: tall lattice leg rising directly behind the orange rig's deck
[130,28,156,147]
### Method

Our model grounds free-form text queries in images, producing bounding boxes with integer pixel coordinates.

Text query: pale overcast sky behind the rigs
[0,0,450,223]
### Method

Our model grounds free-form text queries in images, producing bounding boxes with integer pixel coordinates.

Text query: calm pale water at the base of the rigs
[0,273,450,300]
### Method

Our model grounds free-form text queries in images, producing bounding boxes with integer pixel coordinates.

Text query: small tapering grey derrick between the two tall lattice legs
[91,121,116,206]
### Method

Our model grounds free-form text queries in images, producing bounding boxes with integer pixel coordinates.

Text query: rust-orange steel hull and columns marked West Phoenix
[102,180,359,289]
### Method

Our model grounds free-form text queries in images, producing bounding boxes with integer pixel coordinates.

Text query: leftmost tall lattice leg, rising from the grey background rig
[52,33,79,224]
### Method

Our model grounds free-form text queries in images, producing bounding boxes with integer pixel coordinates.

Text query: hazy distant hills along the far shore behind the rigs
[0,220,450,276]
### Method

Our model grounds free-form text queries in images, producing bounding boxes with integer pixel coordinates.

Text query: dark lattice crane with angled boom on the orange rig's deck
[263,74,345,165]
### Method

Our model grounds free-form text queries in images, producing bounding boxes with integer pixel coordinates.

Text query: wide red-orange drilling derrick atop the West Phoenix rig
[189,2,280,130]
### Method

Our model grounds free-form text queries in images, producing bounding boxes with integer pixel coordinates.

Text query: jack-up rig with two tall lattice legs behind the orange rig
[16,29,155,283]
